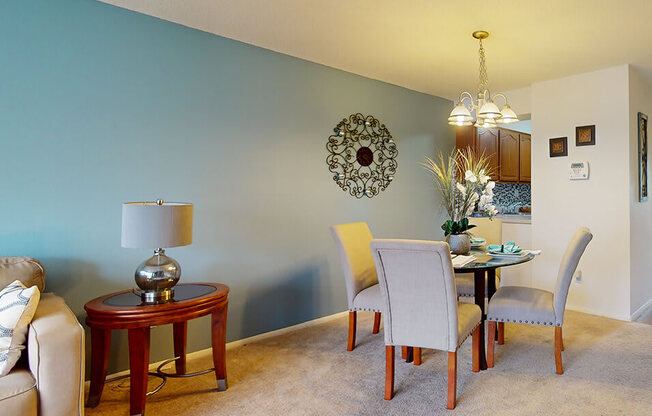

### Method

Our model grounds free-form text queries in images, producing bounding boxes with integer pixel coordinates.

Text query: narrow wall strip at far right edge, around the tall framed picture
[629,67,652,314]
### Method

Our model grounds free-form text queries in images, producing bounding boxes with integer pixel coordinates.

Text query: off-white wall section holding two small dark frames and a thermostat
[532,65,630,320]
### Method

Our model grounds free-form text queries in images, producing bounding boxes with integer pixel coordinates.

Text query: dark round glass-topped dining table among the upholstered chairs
[455,249,536,370]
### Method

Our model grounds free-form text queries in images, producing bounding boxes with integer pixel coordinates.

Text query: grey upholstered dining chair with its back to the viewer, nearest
[371,240,484,409]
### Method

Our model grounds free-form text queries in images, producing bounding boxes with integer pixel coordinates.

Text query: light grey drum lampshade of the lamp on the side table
[122,202,193,249]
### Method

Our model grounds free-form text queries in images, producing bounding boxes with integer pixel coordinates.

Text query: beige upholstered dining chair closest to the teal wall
[331,222,381,351]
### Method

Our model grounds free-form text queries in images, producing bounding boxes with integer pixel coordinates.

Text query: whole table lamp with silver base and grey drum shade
[122,199,193,303]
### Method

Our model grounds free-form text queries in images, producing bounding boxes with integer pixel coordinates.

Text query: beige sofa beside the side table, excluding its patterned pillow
[0,257,84,416]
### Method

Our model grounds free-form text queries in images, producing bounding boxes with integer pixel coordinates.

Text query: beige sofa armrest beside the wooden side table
[27,293,84,416]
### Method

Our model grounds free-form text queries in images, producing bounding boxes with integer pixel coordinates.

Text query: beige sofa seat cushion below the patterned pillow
[0,368,38,415]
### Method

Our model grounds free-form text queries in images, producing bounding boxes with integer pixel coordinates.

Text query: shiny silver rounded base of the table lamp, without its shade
[135,248,181,303]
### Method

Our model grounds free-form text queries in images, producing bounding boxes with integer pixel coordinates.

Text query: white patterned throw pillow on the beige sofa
[0,280,41,377]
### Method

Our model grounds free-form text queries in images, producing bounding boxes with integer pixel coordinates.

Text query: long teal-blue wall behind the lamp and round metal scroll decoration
[0,0,455,372]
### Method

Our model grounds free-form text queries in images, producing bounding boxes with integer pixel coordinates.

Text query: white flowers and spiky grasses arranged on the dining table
[423,149,498,236]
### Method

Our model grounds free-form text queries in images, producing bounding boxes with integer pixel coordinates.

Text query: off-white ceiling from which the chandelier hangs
[100,0,652,98]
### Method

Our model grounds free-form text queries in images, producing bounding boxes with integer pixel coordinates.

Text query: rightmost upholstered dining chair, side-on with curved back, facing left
[487,227,593,374]
